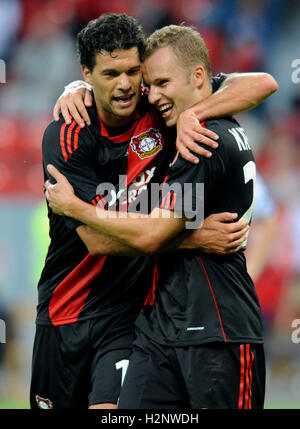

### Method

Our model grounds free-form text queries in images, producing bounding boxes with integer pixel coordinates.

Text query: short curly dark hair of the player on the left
[77,13,145,71]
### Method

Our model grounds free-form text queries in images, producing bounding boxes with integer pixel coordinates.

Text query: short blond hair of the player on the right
[144,25,211,80]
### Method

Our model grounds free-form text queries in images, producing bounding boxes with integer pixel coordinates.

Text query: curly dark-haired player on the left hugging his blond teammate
[31,14,278,408]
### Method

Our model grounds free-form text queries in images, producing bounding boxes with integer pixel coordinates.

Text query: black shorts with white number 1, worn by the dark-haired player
[30,317,134,409]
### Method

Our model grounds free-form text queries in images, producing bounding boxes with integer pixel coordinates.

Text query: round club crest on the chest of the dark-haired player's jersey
[130,128,162,159]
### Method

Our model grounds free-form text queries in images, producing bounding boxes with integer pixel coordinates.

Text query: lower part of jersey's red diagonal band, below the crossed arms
[49,254,106,326]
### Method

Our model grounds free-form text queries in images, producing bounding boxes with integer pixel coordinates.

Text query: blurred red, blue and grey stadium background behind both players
[0,0,300,408]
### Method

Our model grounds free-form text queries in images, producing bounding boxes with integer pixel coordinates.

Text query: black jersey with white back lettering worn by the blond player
[137,117,263,346]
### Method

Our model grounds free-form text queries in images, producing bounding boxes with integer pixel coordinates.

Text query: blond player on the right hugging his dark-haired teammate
[45,26,278,409]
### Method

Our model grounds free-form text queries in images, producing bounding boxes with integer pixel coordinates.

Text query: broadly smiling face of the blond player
[143,46,203,127]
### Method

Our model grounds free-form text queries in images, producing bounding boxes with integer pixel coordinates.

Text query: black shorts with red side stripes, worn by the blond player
[118,333,265,409]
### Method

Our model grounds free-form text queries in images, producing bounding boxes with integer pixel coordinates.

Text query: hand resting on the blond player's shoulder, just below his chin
[176,109,219,164]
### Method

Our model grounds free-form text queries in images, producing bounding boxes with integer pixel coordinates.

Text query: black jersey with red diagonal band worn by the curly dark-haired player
[37,77,225,325]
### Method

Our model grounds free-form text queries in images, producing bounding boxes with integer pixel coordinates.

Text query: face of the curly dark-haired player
[82,47,142,126]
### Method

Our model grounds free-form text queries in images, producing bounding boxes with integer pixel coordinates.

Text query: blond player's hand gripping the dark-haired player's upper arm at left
[44,164,75,216]
